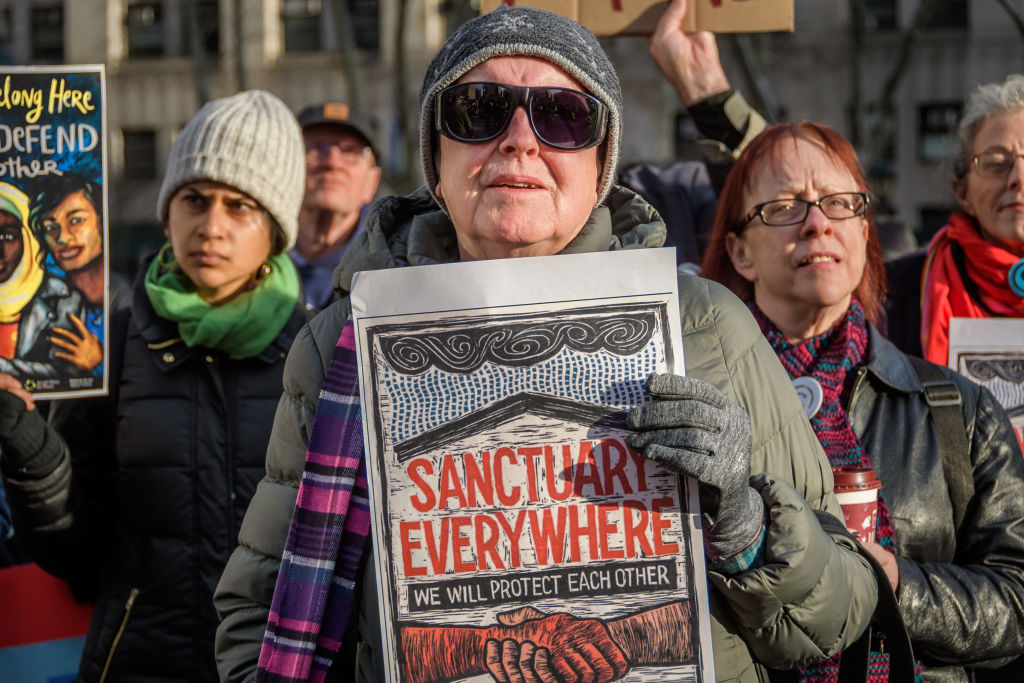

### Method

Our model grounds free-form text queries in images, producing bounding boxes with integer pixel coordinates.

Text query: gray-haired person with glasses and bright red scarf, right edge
[921,74,1024,365]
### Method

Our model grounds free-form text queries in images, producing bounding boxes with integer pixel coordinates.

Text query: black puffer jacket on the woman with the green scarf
[3,268,305,681]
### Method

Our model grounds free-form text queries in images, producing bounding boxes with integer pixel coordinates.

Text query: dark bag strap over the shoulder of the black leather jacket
[906,355,974,533]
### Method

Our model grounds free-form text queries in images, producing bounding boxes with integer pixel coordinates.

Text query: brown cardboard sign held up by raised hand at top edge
[480,0,793,37]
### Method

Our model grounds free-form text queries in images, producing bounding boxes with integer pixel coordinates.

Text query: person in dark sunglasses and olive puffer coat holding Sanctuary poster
[215,7,877,683]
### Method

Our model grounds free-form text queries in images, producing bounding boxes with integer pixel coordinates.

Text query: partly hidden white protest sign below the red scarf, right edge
[949,317,1024,450]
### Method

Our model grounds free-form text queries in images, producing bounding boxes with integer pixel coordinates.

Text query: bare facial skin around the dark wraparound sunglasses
[435,57,601,260]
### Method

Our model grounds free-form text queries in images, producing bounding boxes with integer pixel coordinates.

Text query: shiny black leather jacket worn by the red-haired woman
[848,327,1024,682]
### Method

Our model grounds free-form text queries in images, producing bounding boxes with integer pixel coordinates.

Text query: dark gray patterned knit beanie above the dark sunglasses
[420,5,623,210]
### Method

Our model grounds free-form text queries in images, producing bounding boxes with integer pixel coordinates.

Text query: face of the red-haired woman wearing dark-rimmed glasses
[727,138,867,334]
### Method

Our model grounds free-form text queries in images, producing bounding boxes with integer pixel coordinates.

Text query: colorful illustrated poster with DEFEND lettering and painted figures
[0,66,109,398]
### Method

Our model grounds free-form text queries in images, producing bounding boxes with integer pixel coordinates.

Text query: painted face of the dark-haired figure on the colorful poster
[43,190,103,272]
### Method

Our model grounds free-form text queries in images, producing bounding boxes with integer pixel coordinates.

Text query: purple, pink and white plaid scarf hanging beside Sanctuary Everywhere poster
[256,319,370,683]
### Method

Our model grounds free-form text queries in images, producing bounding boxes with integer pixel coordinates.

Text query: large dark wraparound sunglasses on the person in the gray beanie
[434,83,608,152]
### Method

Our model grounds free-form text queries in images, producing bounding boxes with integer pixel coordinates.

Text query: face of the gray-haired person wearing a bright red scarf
[953,110,1024,254]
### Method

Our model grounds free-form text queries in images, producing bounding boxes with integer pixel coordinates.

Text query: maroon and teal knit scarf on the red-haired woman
[746,299,895,683]
